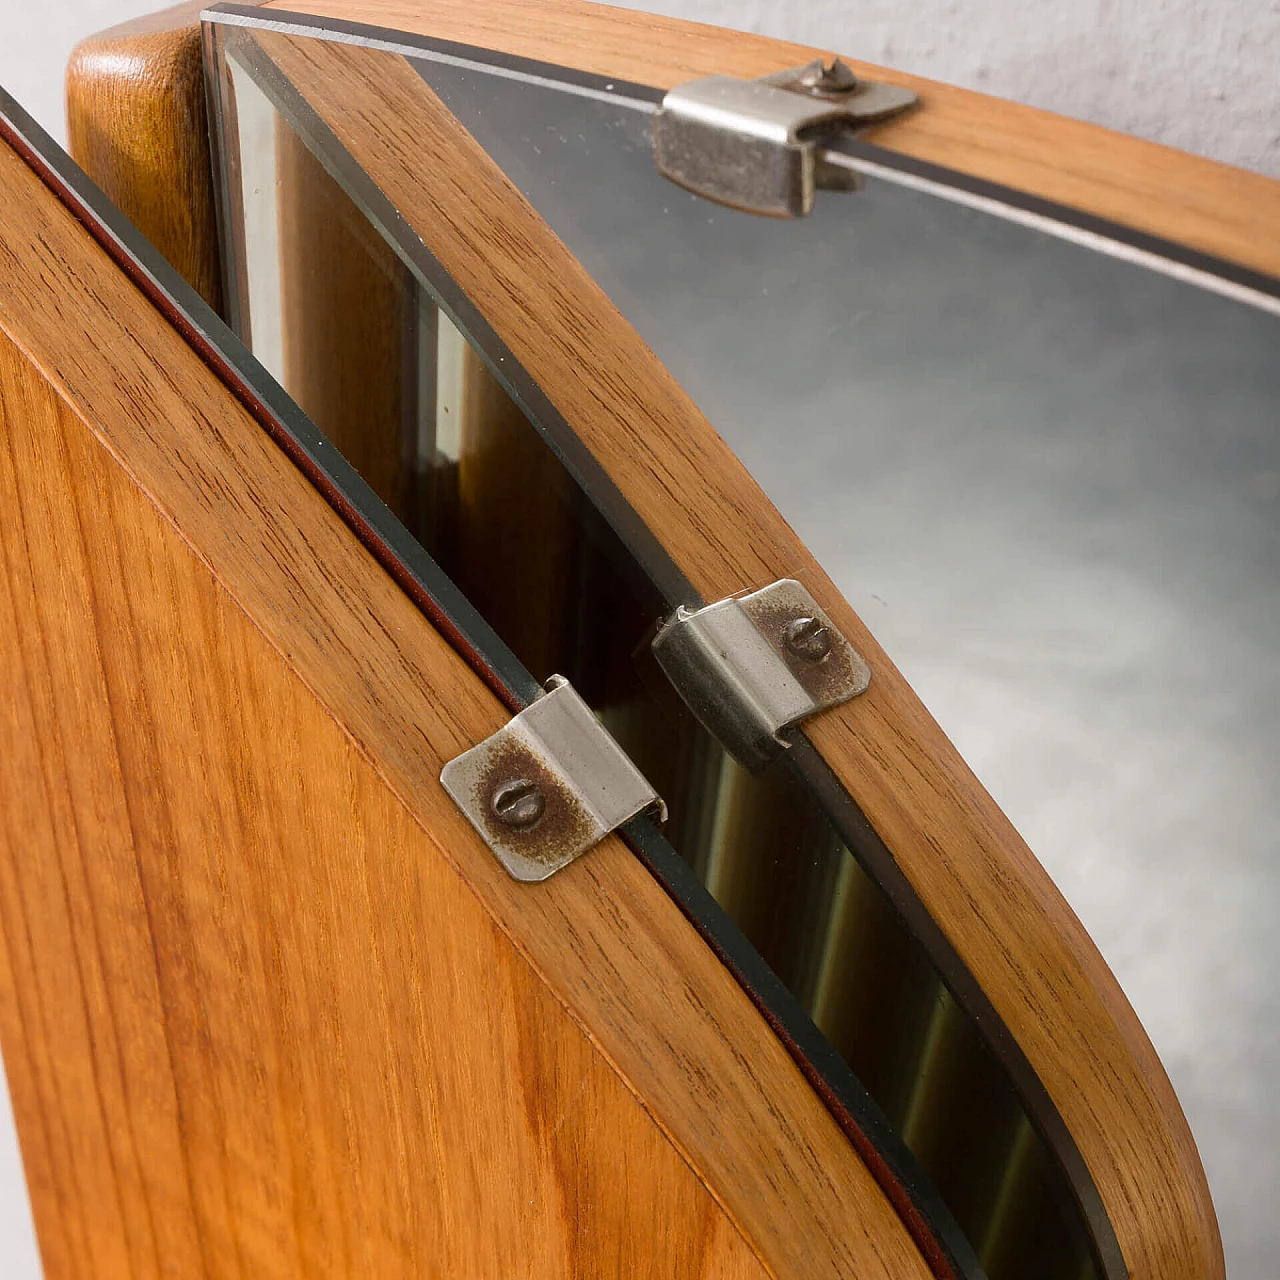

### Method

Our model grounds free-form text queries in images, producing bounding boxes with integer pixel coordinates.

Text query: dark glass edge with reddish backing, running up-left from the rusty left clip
[0,90,541,710]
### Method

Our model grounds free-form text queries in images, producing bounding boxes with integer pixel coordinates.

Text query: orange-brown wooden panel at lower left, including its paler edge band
[0,132,928,1280]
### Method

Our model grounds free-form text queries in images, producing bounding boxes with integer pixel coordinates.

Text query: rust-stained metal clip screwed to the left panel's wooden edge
[440,676,667,881]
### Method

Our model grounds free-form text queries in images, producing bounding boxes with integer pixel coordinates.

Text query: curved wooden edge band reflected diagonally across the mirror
[247,30,1224,1280]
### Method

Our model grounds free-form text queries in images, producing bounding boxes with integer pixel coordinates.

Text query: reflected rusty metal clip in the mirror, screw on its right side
[653,579,872,771]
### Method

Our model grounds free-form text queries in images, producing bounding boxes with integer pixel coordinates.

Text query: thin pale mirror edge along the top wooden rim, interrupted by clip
[209,3,1280,307]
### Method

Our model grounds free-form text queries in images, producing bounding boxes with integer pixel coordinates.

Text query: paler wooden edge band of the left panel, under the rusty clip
[0,129,929,1280]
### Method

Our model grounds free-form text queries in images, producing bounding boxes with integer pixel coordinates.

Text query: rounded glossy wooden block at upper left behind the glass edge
[67,0,223,312]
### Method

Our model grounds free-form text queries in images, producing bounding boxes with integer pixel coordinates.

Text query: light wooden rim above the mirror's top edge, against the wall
[264,0,1280,276]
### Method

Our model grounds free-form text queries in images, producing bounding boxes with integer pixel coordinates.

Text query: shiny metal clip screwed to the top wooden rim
[653,59,919,218]
